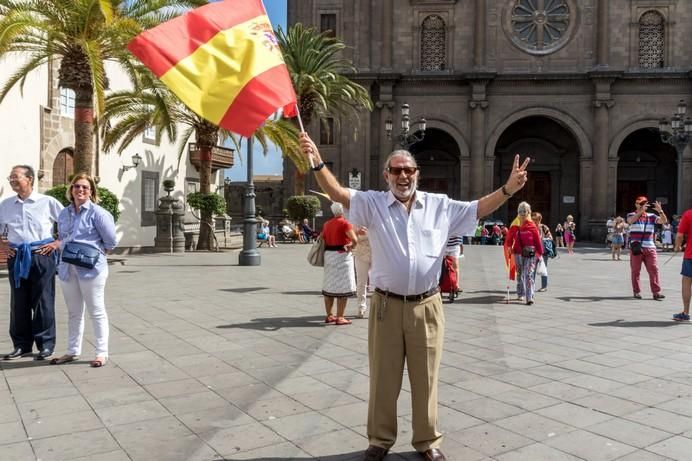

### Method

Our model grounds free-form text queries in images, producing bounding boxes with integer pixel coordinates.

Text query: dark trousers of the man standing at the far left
[7,253,57,352]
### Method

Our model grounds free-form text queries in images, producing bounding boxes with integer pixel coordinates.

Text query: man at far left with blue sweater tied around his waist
[0,165,63,360]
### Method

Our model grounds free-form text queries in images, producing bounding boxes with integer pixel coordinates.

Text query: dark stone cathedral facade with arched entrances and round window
[284,0,692,240]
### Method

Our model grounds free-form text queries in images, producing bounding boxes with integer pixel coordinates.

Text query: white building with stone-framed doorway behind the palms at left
[0,57,233,251]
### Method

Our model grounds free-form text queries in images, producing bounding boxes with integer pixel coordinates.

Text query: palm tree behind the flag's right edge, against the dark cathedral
[276,24,372,195]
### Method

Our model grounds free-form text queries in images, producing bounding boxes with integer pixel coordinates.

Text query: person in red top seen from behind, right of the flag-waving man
[507,202,543,306]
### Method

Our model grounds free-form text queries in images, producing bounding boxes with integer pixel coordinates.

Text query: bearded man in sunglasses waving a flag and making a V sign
[300,133,529,461]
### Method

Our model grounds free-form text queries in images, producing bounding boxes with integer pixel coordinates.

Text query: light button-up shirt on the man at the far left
[0,191,63,245]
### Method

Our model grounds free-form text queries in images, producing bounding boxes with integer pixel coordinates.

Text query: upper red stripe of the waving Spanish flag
[127,0,266,77]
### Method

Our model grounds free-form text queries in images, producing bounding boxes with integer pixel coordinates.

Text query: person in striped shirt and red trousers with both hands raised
[627,196,668,300]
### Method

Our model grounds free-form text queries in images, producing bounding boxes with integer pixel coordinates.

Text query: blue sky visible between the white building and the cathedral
[226,0,286,181]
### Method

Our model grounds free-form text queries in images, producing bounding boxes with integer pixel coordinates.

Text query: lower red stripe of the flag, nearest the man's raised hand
[219,65,296,137]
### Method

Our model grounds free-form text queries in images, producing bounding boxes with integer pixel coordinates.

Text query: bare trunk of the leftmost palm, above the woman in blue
[74,89,94,175]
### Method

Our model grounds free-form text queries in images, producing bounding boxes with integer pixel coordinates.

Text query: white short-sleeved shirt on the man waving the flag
[348,189,478,295]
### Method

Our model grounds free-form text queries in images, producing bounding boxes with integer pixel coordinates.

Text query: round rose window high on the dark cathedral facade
[505,0,577,55]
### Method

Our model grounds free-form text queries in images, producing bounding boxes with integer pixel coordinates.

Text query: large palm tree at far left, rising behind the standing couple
[0,0,207,174]
